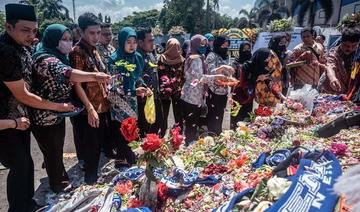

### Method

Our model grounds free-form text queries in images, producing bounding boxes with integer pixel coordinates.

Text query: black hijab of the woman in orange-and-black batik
[242,48,271,85]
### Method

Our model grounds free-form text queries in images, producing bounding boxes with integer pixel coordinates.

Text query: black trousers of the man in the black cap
[0,129,35,212]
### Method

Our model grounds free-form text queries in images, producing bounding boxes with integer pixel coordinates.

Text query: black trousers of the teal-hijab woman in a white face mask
[32,120,69,192]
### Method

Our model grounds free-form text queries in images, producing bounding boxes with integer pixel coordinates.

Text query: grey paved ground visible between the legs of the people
[0,107,230,212]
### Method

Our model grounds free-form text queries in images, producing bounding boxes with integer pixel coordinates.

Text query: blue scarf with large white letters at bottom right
[266,151,341,212]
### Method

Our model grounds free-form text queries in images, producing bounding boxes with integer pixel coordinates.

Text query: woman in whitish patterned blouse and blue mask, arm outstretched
[181,35,226,145]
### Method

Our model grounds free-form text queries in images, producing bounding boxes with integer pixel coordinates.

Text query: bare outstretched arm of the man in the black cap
[4,79,74,112]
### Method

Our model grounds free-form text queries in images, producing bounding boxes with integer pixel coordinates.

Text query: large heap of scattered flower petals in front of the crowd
[45,96,360,211]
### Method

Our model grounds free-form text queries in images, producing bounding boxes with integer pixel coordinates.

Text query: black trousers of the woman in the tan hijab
[161,99,183,131]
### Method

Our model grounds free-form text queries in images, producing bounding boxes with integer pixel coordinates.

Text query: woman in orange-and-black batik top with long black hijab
[239,48,285,106]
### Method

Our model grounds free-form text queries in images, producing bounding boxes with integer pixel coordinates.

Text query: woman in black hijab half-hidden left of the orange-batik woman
[230,41,253,129]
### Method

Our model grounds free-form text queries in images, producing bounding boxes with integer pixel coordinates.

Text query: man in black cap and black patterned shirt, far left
[0,4,74,212]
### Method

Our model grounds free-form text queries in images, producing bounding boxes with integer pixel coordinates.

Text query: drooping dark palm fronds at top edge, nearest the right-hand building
[291,0,334,27]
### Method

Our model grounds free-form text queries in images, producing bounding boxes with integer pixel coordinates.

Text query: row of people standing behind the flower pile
[0,4,360,212]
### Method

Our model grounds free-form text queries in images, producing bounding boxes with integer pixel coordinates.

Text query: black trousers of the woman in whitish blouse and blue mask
[181,101,201,144]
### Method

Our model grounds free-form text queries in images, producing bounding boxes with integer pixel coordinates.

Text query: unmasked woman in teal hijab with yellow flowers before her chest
[108,27,152,165]
